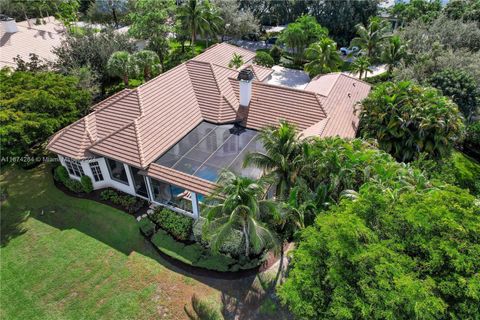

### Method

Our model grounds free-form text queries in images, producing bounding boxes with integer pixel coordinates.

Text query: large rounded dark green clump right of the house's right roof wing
[361,81,464,161]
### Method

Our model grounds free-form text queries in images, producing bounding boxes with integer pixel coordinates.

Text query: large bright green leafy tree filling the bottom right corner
[279,187,480,319]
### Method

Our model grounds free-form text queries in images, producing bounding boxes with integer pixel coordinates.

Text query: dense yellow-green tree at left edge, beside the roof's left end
[0,70,91,157]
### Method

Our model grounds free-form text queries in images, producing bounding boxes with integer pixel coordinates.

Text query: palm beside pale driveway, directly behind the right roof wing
[305,37,342,77]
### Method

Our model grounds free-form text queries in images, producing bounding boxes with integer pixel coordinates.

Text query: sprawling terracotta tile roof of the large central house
[48,43,370,179]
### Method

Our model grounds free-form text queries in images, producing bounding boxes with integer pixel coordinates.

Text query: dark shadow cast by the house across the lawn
[1,168,287,320]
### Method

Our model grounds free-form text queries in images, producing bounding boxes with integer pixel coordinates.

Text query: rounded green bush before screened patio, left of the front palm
[152,207,193,241]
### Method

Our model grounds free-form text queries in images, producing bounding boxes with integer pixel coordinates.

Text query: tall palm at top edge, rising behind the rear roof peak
[178,0,209,50]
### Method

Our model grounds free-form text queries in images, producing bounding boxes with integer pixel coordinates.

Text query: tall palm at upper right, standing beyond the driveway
[352,17,388,59]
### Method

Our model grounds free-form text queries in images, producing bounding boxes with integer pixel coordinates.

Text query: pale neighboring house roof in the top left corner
[0,17,65,68]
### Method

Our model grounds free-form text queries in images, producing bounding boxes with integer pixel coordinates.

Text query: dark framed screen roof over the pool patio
[155,122,264,182]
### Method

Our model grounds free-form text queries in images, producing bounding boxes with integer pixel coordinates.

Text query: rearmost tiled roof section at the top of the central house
[192,42,255,67]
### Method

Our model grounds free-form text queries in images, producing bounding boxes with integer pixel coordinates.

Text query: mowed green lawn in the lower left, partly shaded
[0,166,216,319]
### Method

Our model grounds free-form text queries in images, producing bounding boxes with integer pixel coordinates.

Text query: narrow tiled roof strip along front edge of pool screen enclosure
[147,163,216,194]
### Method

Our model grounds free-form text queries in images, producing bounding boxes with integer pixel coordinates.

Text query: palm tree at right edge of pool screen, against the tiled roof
[244,121,303,199]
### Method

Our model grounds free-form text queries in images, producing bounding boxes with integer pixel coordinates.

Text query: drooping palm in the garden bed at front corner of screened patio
[205,171,277,257]
